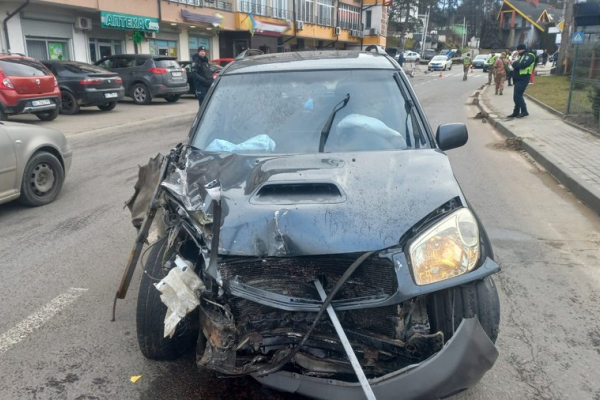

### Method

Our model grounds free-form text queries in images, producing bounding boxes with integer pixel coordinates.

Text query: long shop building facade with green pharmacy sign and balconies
[0,0,387,62]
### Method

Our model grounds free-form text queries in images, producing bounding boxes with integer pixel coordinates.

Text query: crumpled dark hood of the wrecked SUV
[162,149,466,257]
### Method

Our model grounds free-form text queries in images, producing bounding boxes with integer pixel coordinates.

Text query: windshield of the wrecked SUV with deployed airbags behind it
[191,70,422,154]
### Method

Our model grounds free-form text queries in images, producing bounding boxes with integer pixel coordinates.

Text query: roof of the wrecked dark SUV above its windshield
[223,50,397,75]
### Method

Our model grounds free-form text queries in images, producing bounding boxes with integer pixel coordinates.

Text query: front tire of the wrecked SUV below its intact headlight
[427,276,500,343]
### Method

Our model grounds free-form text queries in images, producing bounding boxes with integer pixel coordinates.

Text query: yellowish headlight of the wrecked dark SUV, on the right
[408,208,479,285]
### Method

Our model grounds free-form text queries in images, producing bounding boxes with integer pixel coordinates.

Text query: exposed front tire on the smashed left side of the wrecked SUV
[136,240,198,361]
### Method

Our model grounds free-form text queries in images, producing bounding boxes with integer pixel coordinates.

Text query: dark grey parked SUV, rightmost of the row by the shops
[95,54,190,104]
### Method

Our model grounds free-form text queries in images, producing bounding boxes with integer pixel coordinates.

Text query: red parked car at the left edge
[0,54,61,121]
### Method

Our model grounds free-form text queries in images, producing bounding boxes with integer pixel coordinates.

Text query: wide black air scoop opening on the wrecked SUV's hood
[250,182,346,204]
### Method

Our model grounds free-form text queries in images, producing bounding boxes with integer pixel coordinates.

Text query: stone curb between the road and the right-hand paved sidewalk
[475,88,600,214]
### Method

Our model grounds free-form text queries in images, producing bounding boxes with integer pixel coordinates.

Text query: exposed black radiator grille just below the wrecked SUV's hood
[220,254,398,300]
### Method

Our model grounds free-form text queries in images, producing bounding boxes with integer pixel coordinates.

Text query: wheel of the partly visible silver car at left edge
[19,151,65,206]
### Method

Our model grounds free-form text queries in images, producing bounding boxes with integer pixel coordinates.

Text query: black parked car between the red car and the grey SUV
[42,61,125,115]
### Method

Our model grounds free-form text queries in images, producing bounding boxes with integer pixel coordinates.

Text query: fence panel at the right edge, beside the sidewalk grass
[567,35,600,131]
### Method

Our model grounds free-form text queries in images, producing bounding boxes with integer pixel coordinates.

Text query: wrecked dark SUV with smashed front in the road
[117,52,500,400]
